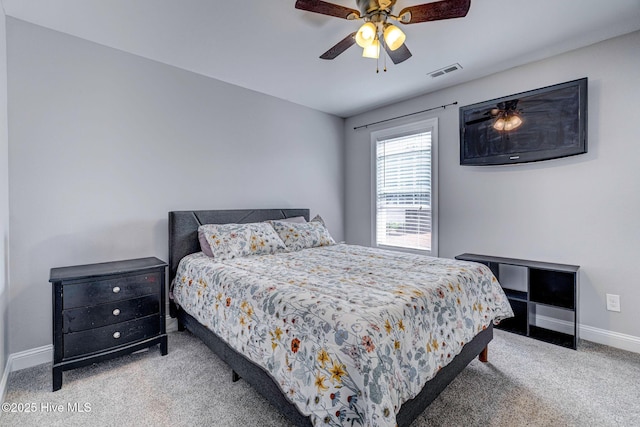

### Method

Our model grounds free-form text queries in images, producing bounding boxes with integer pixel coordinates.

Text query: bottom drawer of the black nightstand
[64,315,160,358]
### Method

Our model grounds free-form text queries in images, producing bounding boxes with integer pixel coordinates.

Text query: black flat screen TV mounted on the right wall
[460,77,587,166]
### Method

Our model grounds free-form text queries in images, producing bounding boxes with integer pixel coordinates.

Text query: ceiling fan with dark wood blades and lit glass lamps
[296,0,471,64]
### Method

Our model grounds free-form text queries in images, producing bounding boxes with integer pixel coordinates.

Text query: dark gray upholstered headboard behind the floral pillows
[169,209,309,283]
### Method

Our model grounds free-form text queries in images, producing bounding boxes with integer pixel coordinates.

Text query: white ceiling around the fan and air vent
[1,0,640,117]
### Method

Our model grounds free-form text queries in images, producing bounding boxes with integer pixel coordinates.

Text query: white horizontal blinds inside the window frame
[376,131,432,251]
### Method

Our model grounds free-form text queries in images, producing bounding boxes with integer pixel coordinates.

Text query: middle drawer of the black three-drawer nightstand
[62,295,160,334]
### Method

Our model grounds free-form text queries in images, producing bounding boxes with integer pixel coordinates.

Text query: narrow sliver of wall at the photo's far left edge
[0,11,9,382]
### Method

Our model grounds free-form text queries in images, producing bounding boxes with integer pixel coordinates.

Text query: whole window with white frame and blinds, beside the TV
[372,119,437,256]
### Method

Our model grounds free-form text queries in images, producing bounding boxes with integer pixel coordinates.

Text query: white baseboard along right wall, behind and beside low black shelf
[536,315,640,353]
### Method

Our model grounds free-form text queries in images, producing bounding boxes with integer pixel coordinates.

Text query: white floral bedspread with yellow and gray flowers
[173,244,513,426]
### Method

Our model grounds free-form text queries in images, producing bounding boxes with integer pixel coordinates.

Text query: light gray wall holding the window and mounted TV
[345,32,640,348]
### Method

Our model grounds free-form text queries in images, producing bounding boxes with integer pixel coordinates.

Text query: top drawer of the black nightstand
[62,273,161,309]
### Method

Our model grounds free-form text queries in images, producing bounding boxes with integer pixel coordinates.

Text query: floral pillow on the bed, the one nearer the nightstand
[198,222,287,260]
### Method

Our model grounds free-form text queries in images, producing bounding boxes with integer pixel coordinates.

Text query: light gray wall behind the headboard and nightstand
[7,18,344,353]
